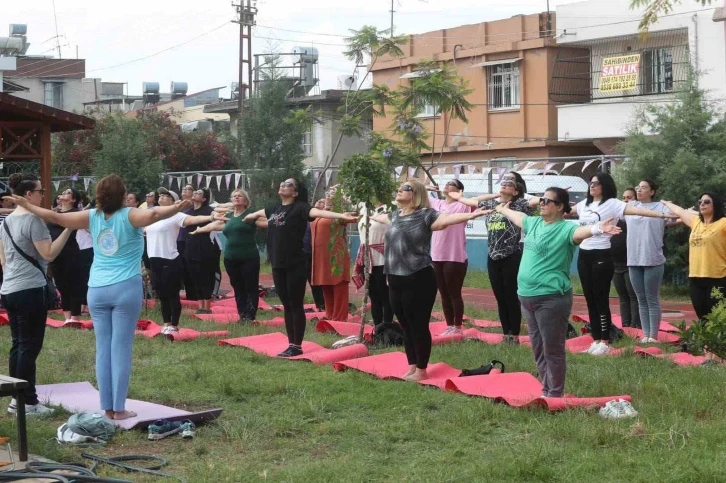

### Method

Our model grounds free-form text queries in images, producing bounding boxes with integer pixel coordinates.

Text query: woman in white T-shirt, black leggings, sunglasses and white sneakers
[572,173,675,356]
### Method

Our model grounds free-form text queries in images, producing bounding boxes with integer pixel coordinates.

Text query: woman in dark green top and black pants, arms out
[192,189,266,322]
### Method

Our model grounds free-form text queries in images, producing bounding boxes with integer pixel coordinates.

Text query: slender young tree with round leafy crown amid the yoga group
[338,151,396,341]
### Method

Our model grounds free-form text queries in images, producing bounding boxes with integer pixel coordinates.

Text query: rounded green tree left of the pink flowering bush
[93,114,163,197]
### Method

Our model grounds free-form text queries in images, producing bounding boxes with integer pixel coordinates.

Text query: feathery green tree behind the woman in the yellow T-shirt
[616,77,726,280]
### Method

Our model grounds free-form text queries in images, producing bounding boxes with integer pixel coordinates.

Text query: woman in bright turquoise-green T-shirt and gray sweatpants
[496,188,621,397]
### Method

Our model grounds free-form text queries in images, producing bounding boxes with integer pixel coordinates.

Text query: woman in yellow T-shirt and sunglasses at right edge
[662,191,726,322]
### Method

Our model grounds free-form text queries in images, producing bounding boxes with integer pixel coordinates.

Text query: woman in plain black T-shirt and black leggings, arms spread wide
[244,178,357,357]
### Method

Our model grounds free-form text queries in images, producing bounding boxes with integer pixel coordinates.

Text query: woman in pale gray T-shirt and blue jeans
[625,179,670,344]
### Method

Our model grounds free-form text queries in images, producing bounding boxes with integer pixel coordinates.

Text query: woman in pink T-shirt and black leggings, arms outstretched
[428,179,472,335]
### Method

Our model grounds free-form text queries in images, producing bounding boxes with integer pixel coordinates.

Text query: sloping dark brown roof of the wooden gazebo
[0,92,96,132]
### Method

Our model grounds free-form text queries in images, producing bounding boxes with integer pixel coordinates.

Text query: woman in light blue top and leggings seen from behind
[7,175,199,420]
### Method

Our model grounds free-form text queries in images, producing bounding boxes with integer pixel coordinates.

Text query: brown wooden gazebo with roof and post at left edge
[0,92,96,208]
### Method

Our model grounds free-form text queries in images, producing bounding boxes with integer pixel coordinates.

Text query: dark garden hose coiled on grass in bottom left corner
[0,453,186,483]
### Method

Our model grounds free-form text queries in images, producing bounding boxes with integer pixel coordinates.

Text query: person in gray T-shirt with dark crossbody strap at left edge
[0,174,71,416]
